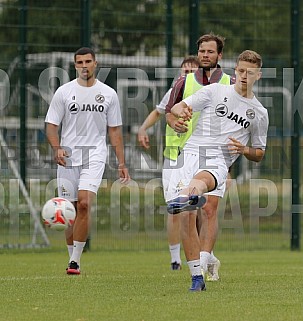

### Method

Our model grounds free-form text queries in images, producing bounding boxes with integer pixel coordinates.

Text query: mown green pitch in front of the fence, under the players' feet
[0,250,303,321]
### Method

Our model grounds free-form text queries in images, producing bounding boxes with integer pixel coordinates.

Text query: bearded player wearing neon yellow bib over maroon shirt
[163,33,234,281]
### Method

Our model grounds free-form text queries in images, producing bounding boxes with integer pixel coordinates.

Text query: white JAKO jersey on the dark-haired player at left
[45,79,122,166]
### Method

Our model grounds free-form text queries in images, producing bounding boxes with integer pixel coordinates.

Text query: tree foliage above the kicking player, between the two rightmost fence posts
[200,0,290,66]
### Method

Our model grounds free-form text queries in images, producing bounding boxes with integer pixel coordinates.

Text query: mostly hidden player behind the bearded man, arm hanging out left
[138,56,200,270]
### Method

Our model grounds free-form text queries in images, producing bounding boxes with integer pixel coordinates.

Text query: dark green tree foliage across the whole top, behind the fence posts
[0,0,300,68]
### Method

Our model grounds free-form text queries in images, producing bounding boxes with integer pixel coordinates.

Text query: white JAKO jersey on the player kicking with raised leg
[183,83,268,167]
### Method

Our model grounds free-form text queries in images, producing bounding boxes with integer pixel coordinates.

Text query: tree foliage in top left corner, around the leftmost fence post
[0,0,80,66]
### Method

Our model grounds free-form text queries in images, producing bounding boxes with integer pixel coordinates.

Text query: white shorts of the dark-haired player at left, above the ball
[57,162,105,202]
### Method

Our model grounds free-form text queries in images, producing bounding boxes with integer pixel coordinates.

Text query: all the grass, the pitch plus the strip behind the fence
[0,182,303,321]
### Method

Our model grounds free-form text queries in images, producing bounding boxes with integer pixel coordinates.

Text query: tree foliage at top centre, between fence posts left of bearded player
[92,0,166,55]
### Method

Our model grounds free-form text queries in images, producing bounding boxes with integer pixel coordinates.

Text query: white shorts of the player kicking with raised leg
[162,152,228,202]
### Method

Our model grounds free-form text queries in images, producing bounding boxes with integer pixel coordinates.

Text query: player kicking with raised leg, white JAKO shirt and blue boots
[167,50,268,291]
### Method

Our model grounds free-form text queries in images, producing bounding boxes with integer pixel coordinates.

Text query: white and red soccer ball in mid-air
[41,197,76,231]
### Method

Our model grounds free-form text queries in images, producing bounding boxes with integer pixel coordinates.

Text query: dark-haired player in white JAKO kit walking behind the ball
[45,47,130,274]
